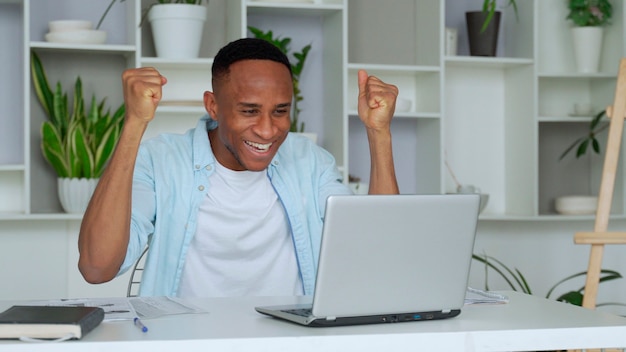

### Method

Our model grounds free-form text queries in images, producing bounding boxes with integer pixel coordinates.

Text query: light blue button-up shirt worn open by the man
[119,115,351,296]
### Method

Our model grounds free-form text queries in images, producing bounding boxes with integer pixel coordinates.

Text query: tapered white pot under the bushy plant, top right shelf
[572,27,603,73]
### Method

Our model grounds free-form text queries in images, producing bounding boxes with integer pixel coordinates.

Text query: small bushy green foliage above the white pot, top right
[566,0,613,27]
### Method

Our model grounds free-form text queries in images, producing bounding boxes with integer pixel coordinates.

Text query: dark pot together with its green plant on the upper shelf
[465,0,517,56]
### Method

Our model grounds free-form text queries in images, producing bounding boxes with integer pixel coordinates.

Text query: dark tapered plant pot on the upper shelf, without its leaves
[465,11,502,56]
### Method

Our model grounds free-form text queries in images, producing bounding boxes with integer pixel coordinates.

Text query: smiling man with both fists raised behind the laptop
[78,38,398,296]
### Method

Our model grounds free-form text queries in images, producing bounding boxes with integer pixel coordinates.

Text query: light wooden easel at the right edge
[574,58,626,309]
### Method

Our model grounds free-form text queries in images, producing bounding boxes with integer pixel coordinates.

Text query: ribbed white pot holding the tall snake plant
[57,177,98,214]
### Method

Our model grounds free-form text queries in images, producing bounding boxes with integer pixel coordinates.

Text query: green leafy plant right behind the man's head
[248,26,311,132]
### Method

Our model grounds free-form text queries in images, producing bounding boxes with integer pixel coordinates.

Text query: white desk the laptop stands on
[0,292,626,352]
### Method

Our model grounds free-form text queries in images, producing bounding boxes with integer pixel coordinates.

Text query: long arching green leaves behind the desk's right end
[472,254,626,307]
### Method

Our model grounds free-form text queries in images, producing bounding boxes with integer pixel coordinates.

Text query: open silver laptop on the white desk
[255,194,480,326]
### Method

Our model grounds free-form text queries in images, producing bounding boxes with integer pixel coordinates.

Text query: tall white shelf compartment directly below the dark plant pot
[443,65,536,216]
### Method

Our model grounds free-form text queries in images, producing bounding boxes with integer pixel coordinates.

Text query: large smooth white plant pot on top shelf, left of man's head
[148,4,207,59]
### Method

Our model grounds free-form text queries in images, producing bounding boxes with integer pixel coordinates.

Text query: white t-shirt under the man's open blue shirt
[178,163,303,297]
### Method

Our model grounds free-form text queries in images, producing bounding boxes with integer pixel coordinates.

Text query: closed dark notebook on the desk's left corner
[0,306,104,339]
